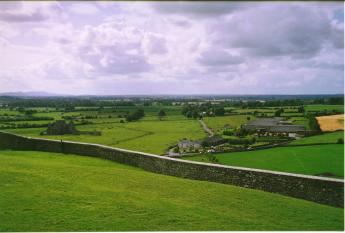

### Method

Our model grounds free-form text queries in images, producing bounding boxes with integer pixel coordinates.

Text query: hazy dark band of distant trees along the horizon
[0,96,344,109]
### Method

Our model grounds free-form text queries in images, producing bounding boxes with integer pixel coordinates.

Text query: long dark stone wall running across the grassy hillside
[0,132,344,208]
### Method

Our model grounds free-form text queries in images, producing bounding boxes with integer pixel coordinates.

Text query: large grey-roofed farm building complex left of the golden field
[242,117,306,137]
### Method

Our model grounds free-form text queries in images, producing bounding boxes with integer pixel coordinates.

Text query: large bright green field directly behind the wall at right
[186,144,344,178]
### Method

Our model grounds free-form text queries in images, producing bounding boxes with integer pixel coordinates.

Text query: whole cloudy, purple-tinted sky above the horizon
[0,1,344,95]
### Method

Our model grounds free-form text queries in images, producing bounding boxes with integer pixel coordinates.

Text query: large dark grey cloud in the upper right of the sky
[214,4,341,58]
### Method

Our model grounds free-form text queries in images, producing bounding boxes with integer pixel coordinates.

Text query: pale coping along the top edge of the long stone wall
[0,131,344,183]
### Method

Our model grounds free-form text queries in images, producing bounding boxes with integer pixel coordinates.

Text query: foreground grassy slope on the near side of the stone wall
[0,151,344,231]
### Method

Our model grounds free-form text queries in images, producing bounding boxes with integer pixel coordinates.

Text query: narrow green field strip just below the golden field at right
[290,131,344,145]
